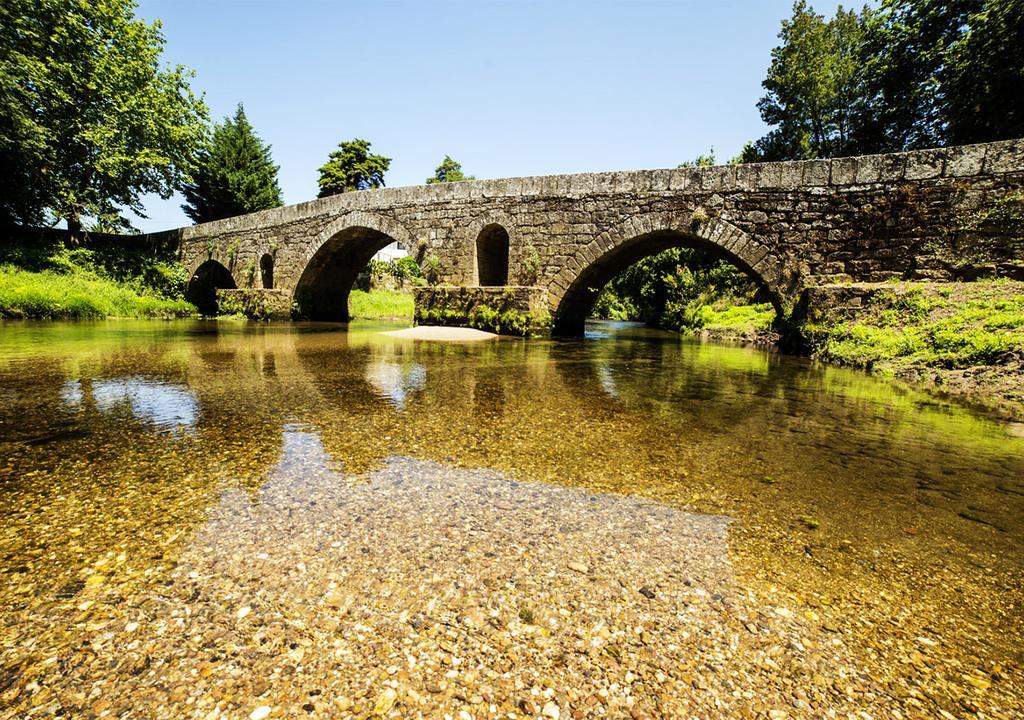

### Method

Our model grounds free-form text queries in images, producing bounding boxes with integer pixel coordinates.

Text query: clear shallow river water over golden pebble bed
[0,322,1024,717]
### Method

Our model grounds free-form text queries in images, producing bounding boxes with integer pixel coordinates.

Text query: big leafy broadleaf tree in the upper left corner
[0,0,206,237]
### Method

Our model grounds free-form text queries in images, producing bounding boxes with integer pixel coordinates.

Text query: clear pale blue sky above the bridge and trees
[136,0,837,230]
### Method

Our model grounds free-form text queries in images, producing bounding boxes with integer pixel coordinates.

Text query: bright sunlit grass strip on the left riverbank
[0,265,196,320]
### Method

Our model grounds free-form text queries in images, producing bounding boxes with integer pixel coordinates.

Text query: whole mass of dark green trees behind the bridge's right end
[743,0,1024,161]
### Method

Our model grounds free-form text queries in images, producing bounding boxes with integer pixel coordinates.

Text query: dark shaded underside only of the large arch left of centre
[295,226,395,323]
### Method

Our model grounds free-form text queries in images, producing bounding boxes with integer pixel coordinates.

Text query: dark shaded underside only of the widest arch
[554,230,782,336]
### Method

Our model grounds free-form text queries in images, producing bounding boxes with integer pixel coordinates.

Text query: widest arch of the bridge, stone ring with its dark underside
[548,211,792,335]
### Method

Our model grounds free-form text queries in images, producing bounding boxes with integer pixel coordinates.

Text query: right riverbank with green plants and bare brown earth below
[804,281,1024,420]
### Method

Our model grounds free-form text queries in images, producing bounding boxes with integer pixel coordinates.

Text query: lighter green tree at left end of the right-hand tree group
[743,0,864,160]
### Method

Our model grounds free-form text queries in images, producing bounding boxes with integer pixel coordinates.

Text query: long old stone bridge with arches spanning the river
[174,140,1024,334]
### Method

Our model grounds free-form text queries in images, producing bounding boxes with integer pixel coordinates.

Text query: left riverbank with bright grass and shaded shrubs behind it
[0,241,196,320]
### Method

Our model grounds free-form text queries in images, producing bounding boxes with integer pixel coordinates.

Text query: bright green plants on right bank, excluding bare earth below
[805,282,1024,370]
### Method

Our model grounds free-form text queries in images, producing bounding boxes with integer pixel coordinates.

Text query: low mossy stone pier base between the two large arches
[414,286,551,337]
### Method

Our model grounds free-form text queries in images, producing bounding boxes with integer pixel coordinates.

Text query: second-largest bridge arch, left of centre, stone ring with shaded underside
[294,211,413,322]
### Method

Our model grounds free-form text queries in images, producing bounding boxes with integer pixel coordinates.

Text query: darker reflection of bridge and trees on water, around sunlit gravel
[0,324,1024,717]
